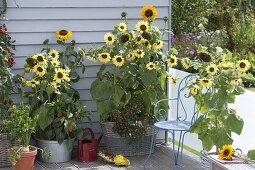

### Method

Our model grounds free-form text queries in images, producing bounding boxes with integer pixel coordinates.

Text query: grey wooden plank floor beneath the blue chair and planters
[0,145,201,170]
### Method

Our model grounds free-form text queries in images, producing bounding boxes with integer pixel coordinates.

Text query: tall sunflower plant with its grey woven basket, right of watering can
[88,6,172,156]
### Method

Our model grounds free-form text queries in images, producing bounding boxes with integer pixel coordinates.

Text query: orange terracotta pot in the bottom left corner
[13,147,37,170]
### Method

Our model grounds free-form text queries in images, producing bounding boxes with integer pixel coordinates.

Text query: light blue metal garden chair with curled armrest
[144,74,198,169]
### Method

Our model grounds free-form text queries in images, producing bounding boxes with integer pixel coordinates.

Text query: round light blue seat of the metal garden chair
[154,120,191,131]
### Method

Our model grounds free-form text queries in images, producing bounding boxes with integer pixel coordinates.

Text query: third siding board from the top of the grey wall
[2,19,167,33]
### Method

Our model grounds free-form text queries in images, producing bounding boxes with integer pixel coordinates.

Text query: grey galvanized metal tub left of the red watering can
[37,139,74,163]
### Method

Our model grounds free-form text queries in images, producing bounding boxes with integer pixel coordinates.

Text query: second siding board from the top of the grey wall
[5,6,168,20]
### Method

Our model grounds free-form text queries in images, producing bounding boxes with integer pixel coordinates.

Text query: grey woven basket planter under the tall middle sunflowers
[100,122,156,156]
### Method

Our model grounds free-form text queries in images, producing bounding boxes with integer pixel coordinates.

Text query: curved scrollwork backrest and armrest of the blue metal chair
[154,74,198,123]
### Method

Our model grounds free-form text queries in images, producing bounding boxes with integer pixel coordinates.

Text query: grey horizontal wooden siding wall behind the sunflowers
[2,0,169,138]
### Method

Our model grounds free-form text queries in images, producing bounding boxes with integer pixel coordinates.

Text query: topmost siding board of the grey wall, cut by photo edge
[5,0,169,8]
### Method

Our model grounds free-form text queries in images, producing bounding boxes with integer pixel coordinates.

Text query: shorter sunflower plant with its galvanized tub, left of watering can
[17,30,88,162]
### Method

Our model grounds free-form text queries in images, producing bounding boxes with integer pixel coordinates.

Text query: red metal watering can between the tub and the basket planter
[78,128,103,162]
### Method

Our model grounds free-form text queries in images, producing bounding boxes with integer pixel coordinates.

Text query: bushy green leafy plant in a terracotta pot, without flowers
[3,103,50,170]
